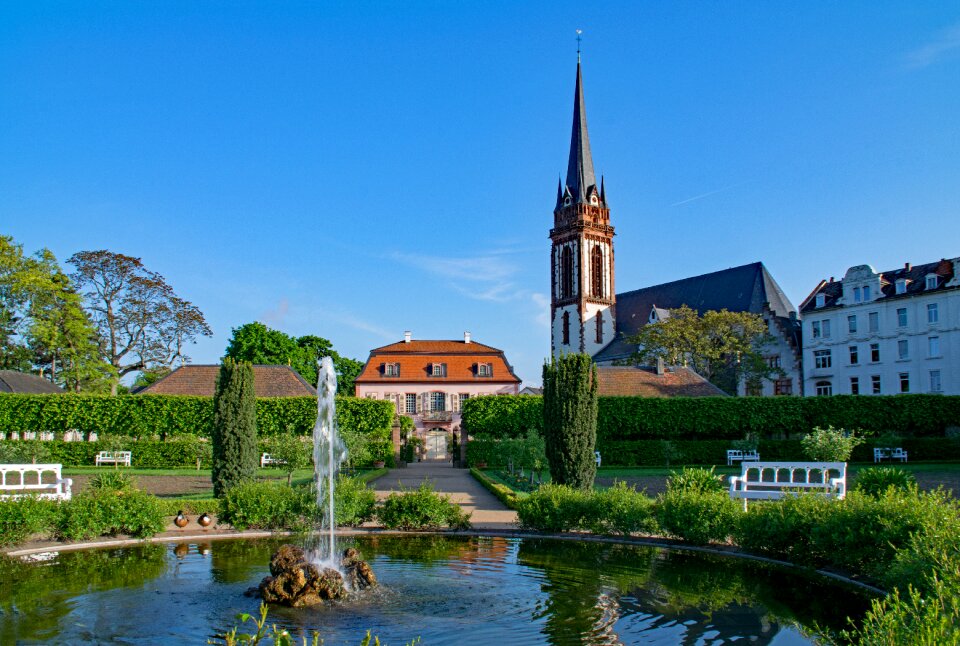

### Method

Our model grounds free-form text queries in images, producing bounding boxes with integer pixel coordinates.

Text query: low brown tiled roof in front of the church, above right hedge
[597,366,726,397]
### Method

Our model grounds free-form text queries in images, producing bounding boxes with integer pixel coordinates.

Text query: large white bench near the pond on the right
[730,462,847,509]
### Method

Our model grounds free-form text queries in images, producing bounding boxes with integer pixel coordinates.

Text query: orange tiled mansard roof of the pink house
[356,340,520,384]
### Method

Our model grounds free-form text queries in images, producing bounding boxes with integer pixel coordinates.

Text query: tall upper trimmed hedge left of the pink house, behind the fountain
[0,393,394,439]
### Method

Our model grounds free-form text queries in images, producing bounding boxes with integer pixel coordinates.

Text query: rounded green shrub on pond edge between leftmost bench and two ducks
[57,489,166,540]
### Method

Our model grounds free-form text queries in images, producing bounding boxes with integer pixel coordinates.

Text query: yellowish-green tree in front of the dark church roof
[627,306,780,394]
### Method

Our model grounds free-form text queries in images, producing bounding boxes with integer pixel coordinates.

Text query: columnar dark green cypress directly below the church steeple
[543,354,597,489]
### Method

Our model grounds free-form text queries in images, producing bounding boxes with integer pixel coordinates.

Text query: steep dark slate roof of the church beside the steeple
[594,262,800,362]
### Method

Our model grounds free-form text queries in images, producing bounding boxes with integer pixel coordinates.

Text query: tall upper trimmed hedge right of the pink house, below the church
[461,395,960,442]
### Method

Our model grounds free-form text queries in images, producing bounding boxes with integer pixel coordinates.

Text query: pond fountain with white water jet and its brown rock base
[258,357,377,607]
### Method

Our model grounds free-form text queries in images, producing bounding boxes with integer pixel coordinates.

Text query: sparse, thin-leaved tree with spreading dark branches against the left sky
[69,249,212,394]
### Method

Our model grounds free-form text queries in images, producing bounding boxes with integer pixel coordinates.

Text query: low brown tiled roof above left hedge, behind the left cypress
[136,365,316,397]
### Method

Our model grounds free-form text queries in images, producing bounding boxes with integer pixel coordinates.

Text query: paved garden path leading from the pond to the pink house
[371,462,517,529]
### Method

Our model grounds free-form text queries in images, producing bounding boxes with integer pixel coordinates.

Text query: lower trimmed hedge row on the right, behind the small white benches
[467,437,960,467]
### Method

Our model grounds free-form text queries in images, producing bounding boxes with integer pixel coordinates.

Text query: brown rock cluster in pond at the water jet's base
[259,545,377,608]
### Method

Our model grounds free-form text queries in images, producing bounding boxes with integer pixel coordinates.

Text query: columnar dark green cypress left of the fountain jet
[211,357,258,498]
